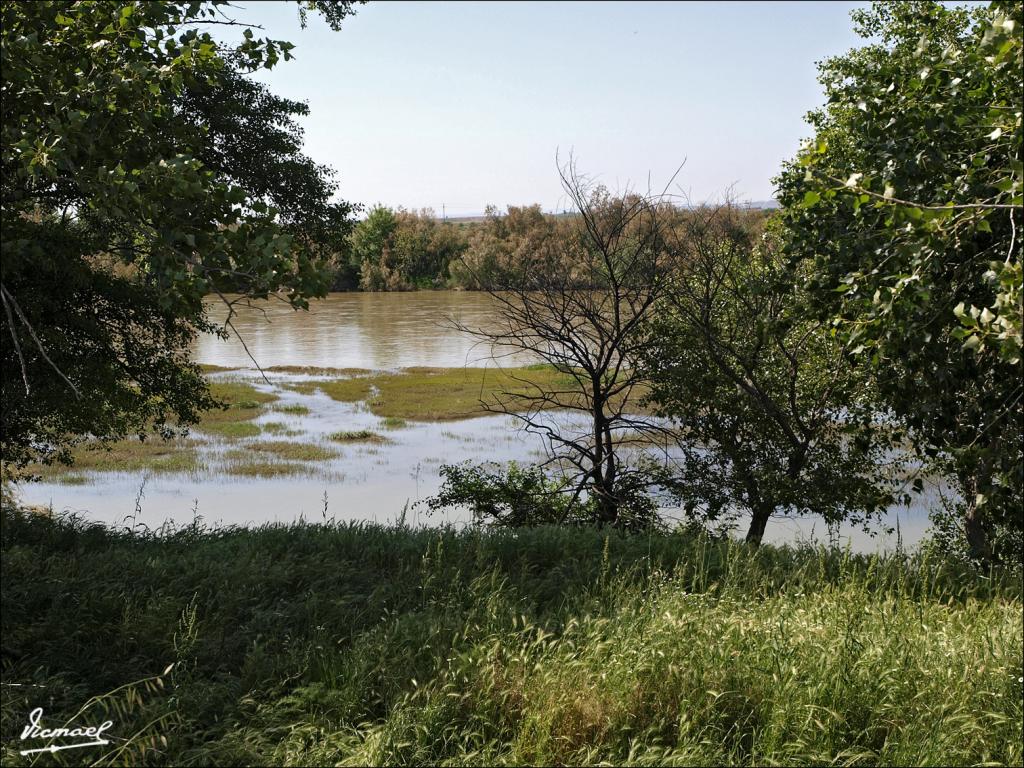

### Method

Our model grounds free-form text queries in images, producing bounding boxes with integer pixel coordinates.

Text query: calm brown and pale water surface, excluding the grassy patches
[23,292,937,551]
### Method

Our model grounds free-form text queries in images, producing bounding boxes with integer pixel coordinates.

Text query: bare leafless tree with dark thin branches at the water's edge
[455,159,676,525]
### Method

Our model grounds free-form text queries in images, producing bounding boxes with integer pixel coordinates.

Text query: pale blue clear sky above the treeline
[228,0,863,216]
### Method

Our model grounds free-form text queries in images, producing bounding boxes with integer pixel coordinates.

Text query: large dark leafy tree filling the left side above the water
[0,2,360,465]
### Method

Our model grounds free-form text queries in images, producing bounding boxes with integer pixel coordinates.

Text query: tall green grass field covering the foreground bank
[0,509,1024,765]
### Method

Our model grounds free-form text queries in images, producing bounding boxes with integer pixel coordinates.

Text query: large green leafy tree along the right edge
[777,2,1024,559]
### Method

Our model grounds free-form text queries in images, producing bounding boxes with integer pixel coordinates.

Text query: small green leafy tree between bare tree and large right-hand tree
[644,206,894,545]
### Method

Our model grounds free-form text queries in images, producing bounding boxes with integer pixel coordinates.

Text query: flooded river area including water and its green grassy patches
[22,292,936,550]
